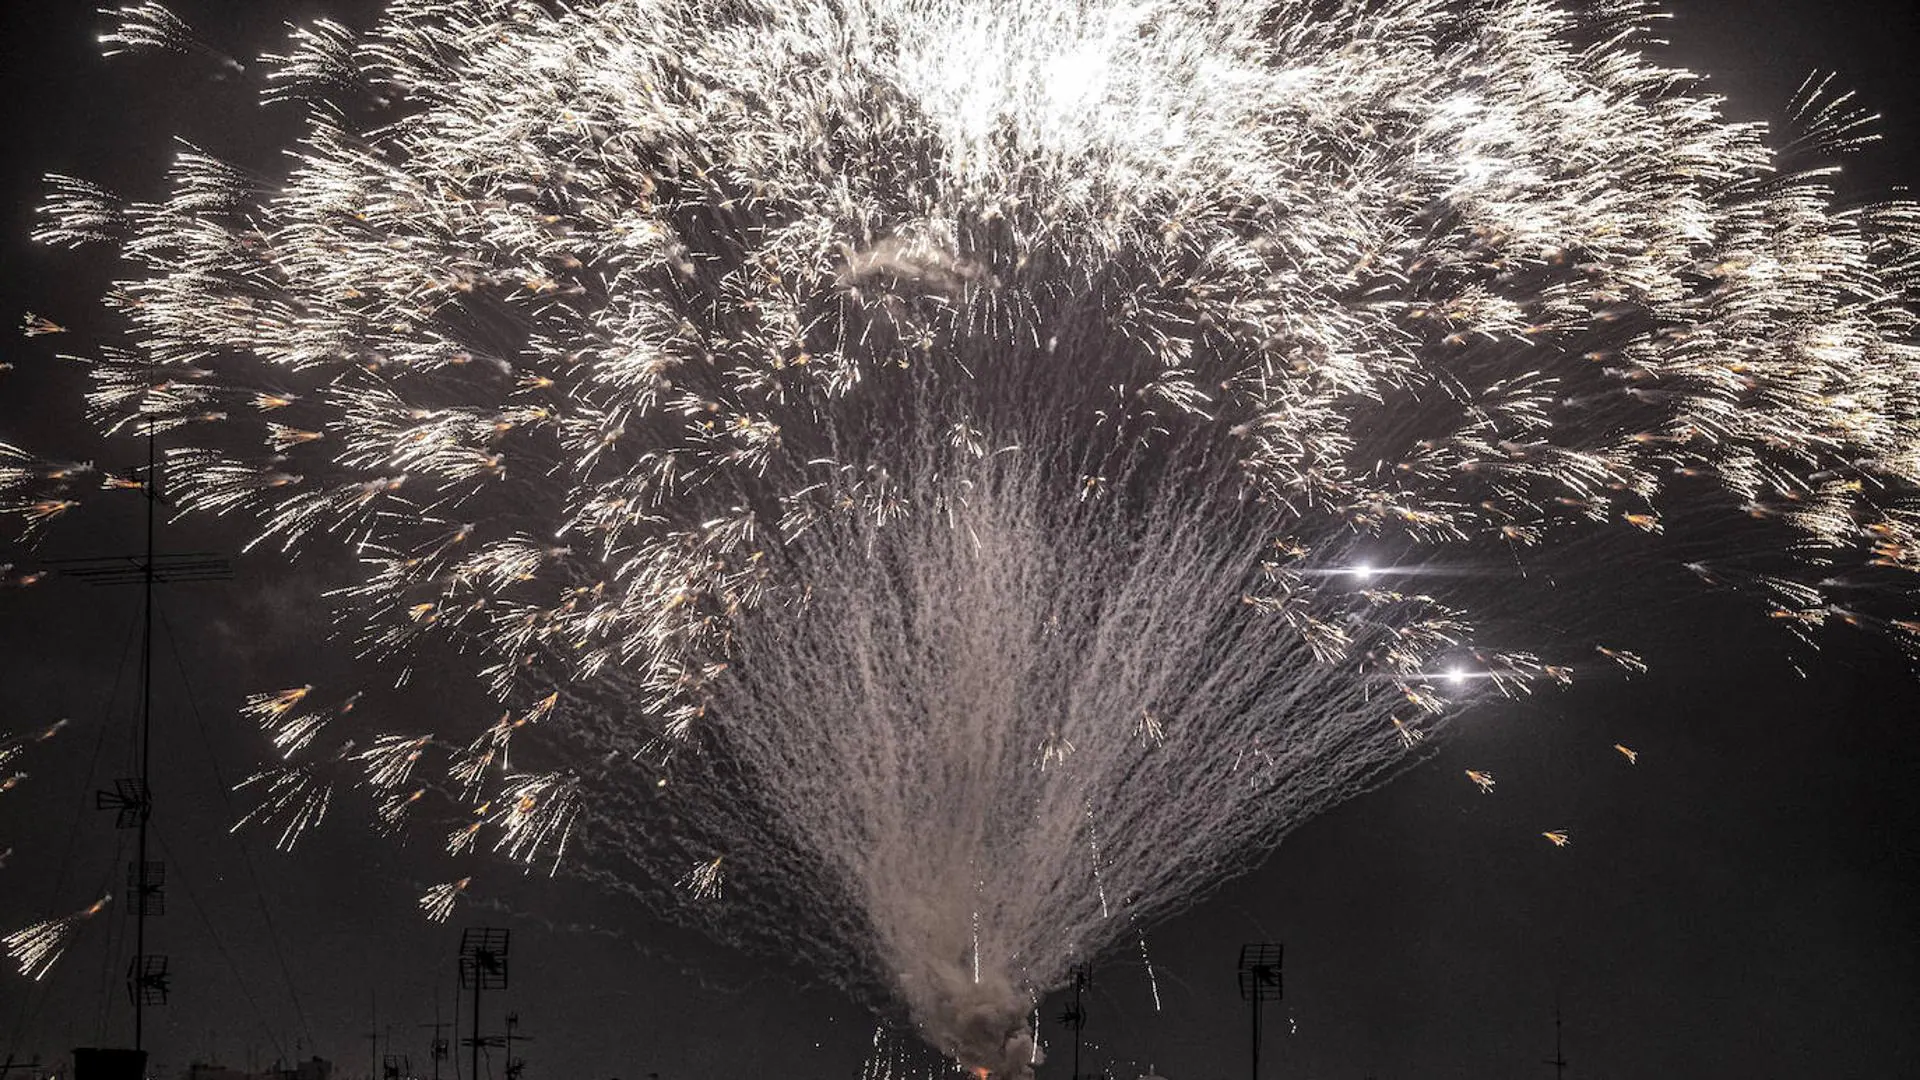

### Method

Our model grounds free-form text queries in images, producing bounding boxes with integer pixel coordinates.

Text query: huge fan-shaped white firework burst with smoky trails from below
[0,0,1920,1076]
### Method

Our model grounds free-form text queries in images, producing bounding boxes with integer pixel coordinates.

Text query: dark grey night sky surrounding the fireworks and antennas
[0,0,1920,1080]
